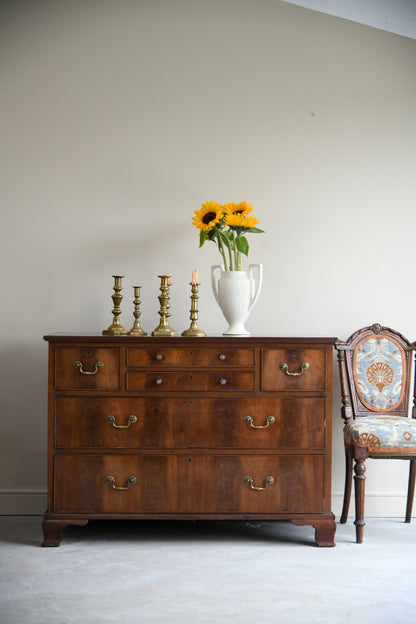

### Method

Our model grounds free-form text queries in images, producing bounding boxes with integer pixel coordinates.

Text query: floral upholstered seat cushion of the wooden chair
[344,416,416,455]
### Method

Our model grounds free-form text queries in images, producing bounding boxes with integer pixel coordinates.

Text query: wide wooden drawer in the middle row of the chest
[55,397,325,449]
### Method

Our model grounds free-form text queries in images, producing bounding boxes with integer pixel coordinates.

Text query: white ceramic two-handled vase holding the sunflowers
[211,264,263,336]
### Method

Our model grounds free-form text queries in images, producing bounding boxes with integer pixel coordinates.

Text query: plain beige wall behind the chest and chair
[0,0,416,516]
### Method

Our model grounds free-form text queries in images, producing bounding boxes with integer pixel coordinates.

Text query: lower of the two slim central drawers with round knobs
[126,370,254,392]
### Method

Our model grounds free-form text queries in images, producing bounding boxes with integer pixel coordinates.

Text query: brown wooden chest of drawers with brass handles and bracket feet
[43,335,336,546]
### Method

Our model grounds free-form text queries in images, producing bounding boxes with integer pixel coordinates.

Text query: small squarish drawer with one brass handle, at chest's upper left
[55,347,120,390]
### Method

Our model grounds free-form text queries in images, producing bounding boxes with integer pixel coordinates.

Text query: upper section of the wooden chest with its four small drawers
[46,336,333,393]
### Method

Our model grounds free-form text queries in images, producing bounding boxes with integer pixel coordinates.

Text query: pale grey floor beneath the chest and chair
[0,516,416,624]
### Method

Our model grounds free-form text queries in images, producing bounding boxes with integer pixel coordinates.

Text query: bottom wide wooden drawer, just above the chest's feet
[55,455,324,514]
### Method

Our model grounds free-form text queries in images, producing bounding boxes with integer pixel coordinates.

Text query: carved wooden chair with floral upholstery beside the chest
[335,324,416,543]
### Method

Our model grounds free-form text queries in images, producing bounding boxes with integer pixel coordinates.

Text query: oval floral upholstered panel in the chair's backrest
[353,335,406,412]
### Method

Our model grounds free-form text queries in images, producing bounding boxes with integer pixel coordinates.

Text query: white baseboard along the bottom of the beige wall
[0,489,416,518]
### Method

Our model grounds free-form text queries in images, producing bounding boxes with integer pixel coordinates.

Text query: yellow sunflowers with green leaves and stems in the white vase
[192,201,264,271]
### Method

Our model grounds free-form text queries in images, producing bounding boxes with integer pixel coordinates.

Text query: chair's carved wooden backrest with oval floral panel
[335,323,415,420]
